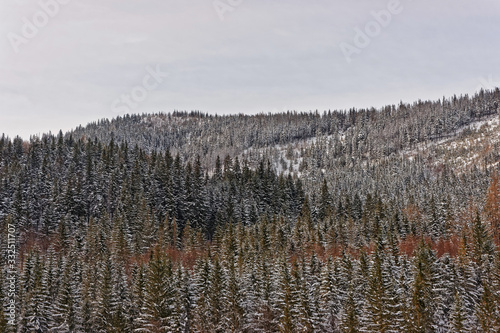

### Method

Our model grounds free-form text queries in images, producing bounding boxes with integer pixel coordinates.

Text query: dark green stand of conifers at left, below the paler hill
[0,134,304,240]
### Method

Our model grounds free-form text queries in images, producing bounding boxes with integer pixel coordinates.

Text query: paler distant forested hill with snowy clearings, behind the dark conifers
[64,89,500,223]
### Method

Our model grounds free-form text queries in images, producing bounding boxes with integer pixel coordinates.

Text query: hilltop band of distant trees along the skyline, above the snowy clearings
[72,89,500,167]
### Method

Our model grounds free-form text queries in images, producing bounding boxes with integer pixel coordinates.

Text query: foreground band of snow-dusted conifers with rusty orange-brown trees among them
[0,201,500,332]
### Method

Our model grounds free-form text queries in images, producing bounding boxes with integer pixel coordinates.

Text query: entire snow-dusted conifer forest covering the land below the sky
[0,89,500,333]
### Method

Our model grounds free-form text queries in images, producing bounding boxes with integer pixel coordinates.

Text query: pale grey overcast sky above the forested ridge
[0,0,500,139]
